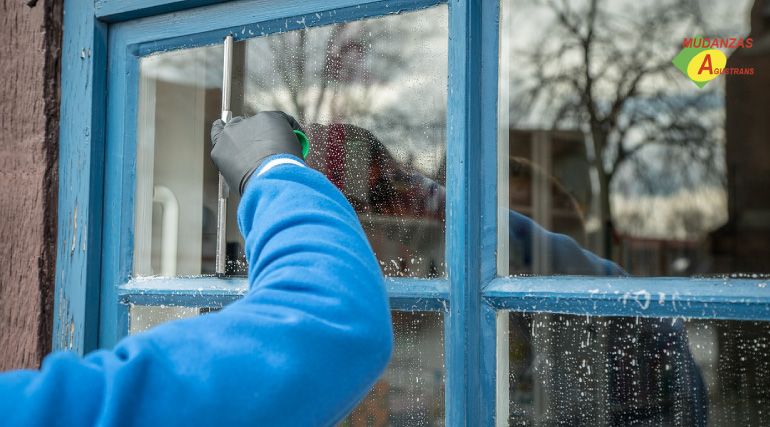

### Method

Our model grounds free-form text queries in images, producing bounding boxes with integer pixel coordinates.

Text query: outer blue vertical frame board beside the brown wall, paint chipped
[53,1,107,355]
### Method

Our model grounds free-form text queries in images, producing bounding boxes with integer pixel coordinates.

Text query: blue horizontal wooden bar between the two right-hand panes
[484,277,770,320]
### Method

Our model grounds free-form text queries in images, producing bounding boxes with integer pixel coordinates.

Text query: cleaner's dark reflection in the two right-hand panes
[508,160,708,426]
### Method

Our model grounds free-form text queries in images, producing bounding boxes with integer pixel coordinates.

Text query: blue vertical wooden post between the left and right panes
[447,0,498,425]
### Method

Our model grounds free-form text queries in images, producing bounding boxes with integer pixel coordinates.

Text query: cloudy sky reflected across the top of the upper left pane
[142,5,448,179]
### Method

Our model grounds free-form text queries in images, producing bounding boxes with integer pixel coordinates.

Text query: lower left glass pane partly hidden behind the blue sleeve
[129,305,446,427]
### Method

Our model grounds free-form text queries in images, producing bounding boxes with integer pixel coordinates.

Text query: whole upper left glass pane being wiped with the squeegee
[134,5,448,278]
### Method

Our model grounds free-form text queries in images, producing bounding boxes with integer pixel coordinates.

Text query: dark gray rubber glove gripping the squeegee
[211,111,302,195]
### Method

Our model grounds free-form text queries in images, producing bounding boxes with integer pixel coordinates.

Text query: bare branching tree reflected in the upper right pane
[511,0,724,256]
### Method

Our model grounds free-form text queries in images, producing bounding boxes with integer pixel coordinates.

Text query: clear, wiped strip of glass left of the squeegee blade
[134,46,222,276]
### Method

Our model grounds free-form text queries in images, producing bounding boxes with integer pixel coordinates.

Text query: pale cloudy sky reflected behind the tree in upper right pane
[501,0,753,238]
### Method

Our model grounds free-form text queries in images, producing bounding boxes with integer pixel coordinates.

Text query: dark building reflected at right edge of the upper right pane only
[712,0,770,273]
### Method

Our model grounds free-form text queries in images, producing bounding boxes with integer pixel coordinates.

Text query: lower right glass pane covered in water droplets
[503,312,770,427]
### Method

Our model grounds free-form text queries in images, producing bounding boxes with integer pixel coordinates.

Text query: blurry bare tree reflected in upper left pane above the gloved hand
[243,17,446,127]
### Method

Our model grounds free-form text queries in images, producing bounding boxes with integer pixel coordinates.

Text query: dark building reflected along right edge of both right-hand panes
[711,0,770,425]
